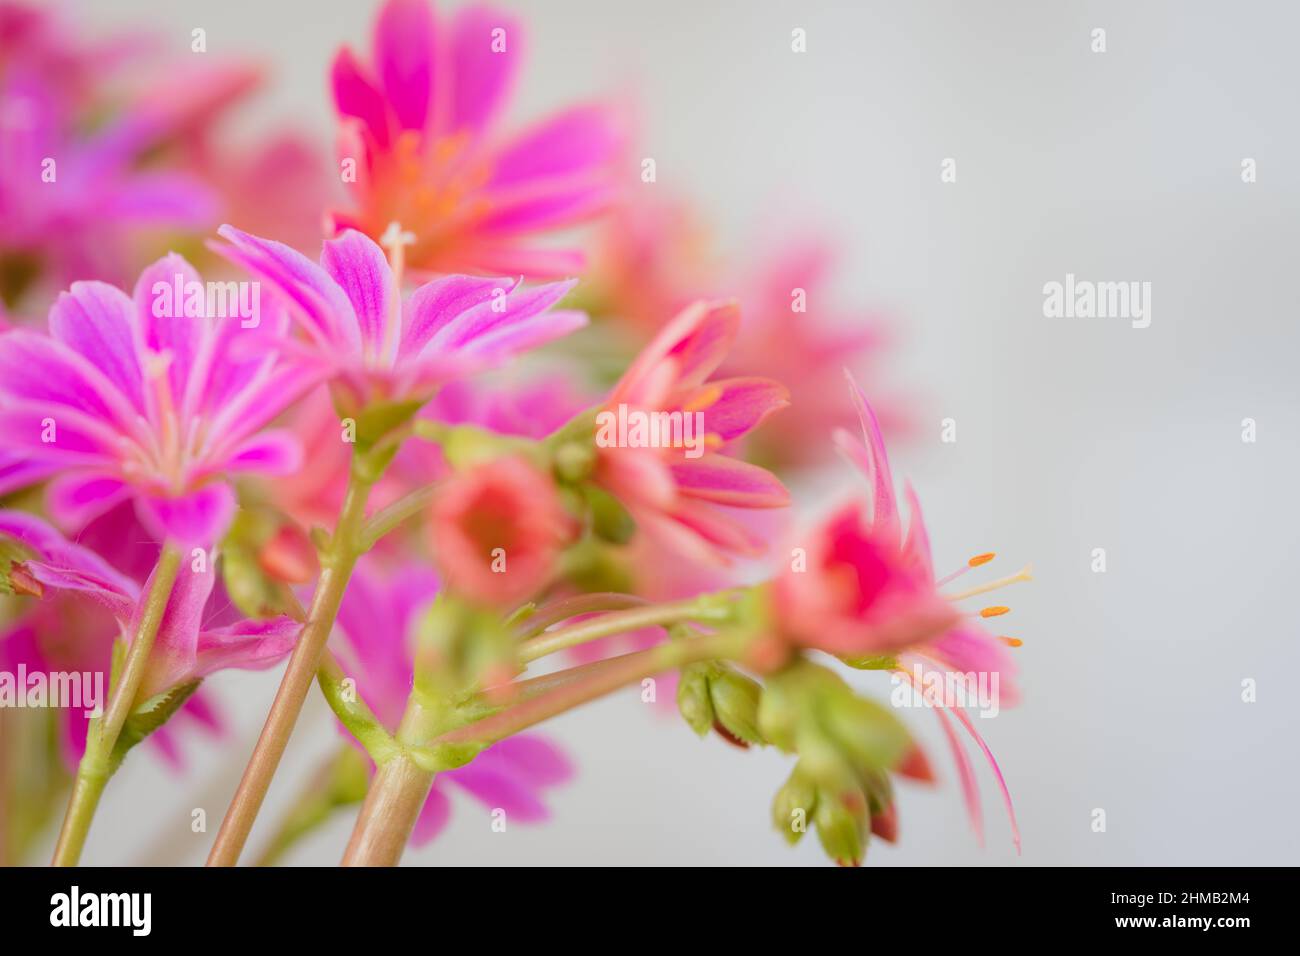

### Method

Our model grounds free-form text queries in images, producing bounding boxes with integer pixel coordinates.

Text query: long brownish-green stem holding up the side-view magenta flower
[208,458,373,866]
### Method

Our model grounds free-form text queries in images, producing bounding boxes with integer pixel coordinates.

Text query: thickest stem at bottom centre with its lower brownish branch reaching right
[343,632,746,866]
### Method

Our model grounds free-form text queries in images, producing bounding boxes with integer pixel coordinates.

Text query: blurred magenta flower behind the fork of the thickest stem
[334,562,573,847]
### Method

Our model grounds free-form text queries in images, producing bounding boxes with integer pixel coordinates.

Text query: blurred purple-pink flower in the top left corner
[0,3,257,302]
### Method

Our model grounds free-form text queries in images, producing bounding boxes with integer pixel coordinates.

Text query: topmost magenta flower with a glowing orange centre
[332,0,620,276]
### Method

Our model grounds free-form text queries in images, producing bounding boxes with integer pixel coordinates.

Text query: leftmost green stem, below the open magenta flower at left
[51,544,181,866]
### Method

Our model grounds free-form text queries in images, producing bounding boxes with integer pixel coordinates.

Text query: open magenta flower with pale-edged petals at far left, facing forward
[0,255,307,546]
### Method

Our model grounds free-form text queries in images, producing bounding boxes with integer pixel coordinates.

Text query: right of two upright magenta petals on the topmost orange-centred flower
[449,7,524,131]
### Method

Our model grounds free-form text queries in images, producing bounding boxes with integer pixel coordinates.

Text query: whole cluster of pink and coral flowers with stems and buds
[0,0,1027,865]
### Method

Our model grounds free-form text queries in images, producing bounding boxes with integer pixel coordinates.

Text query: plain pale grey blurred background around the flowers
[35,0,1300,865]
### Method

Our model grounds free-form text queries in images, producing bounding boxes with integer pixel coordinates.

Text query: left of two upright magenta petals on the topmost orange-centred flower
[374,0,434,130]
